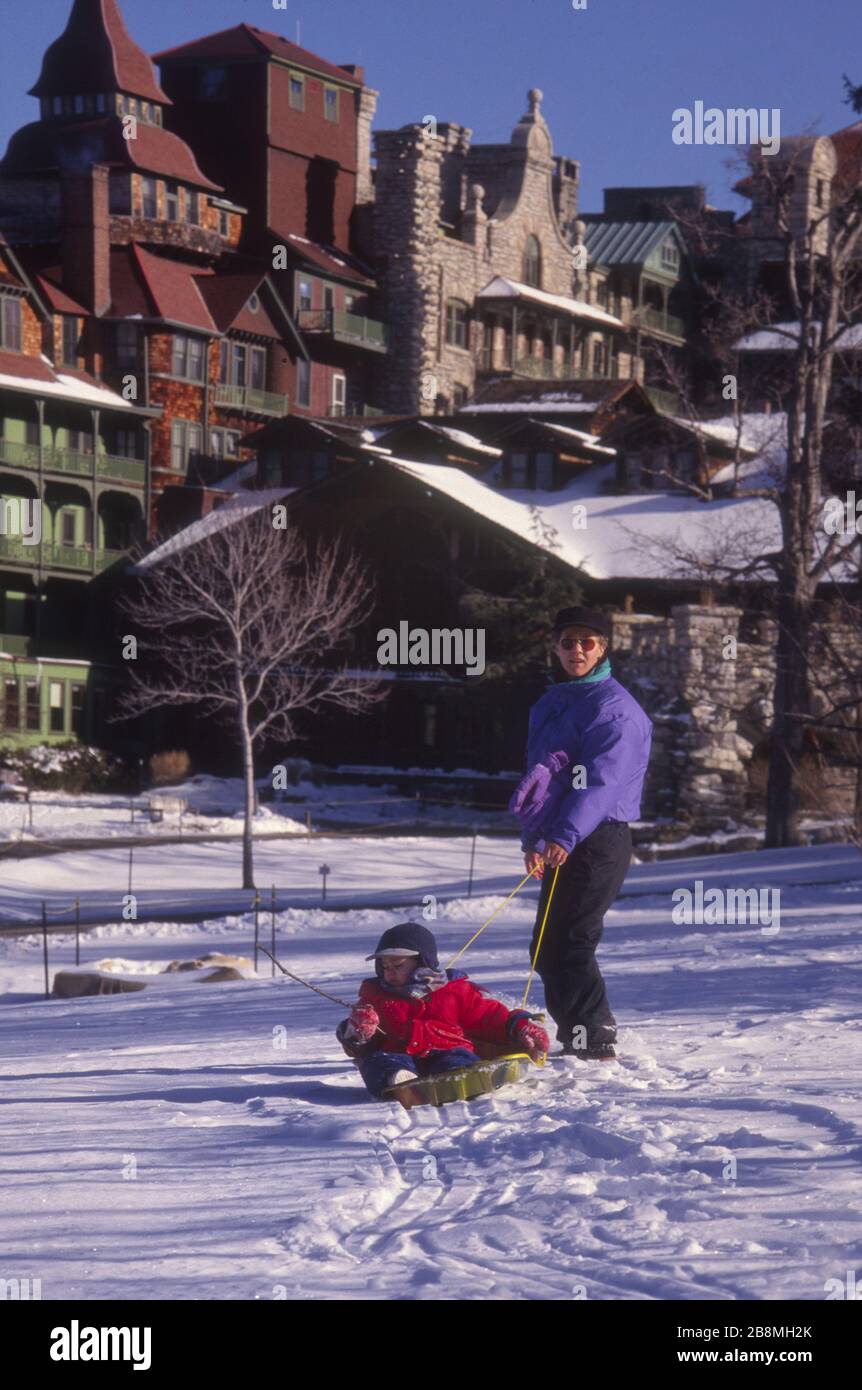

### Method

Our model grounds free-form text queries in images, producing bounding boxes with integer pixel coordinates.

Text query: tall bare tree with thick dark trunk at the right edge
[645,127,862,848]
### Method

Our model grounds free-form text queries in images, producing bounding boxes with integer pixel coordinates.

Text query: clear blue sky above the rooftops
[0,0,862,213]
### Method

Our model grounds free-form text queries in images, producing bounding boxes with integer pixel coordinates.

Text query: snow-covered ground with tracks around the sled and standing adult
[0,840,862,1301]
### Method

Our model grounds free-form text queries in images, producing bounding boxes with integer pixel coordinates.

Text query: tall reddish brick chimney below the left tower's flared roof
[60,164,111,318]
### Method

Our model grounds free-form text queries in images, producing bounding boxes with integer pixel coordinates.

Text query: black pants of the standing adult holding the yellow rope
[530,820,631,1044]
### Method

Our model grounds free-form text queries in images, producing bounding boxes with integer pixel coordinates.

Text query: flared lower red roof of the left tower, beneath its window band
[0,115,222,193]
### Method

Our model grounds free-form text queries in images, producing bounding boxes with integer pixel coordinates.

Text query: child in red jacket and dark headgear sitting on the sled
[335,922,549,1099]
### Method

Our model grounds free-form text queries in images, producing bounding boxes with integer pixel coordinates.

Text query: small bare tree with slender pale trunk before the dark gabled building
[120,507,382,888]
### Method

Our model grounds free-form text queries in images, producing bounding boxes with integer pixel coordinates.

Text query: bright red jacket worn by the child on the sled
[342,976,517,1056]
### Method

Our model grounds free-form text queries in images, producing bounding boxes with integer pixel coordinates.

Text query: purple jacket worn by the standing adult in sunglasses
[509,676,652,852]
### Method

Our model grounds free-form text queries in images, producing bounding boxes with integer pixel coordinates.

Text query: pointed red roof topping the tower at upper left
[29,0,171,106]
